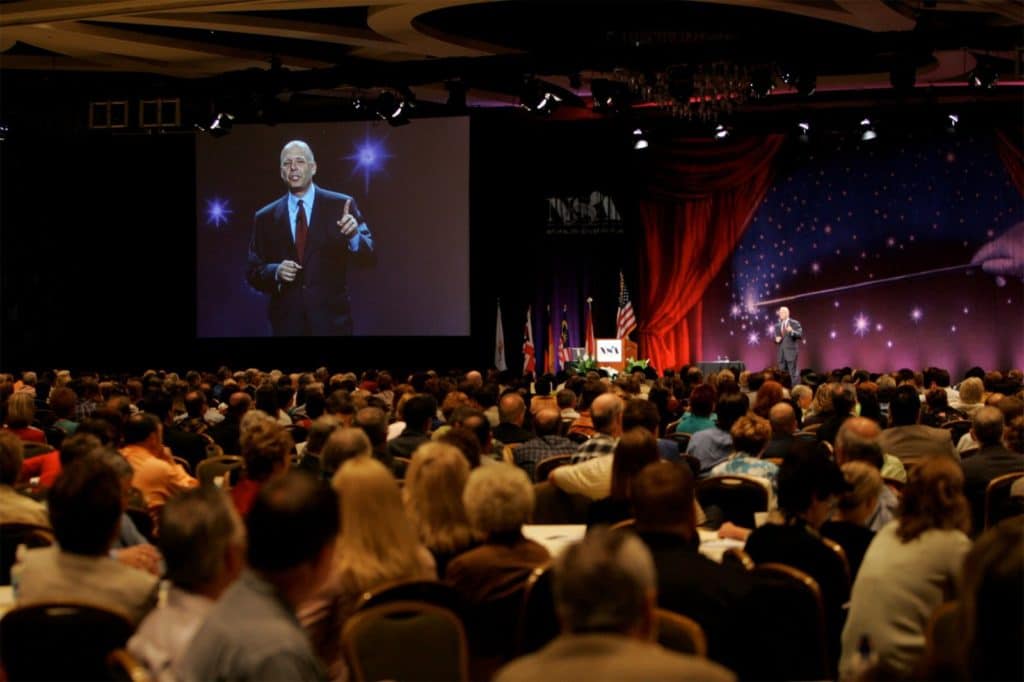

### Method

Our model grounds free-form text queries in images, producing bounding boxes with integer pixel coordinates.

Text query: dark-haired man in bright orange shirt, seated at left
[121,413,198,511]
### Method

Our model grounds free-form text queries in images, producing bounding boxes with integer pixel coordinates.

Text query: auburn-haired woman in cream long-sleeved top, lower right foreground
[840,457,971,679]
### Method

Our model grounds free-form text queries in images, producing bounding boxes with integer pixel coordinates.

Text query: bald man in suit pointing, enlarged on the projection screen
[247,140,374,336]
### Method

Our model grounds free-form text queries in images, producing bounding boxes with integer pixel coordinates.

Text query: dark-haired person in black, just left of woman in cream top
[745,451,850,667]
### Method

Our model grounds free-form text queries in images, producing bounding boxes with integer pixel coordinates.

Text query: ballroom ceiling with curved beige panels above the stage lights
[0,0,1024,116]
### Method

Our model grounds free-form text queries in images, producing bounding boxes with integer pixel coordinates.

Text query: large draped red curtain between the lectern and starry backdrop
[640,135,784,370]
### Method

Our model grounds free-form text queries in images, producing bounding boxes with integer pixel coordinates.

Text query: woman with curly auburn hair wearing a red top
[230,412,294,518]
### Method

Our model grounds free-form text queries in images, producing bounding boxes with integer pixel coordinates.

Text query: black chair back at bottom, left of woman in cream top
[735,563,835,680]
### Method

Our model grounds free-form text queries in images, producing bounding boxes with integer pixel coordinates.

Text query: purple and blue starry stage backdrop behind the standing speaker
[700,135,1024,374]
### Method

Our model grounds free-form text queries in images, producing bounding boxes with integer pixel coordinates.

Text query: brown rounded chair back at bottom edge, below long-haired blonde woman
[341,601,469,682]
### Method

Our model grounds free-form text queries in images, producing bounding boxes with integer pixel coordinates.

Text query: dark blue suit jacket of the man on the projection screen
[246,186,373,336]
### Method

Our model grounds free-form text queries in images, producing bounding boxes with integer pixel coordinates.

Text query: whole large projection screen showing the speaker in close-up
[196,117,470,338]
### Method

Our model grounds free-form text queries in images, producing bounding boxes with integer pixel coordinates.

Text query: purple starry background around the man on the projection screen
[196,118,469,337]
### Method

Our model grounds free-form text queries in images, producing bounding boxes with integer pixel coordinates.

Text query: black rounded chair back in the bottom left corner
[0,602,135,680]
